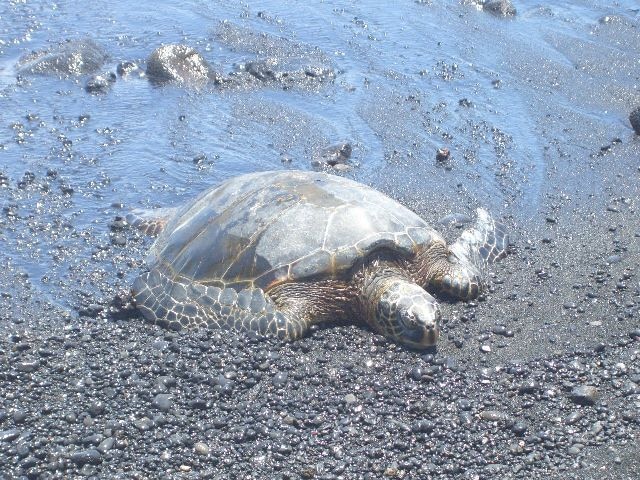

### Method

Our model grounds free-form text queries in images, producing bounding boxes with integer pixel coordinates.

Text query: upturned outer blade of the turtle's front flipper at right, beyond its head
[449,208,509,275]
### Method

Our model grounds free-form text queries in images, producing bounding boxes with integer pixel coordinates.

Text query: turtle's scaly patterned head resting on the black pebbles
[370,279,441,349]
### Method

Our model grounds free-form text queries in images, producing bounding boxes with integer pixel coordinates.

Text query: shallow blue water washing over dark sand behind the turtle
[0,0,640,304]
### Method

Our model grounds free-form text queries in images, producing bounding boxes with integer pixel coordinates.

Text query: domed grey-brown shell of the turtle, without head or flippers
[147,171,442,290]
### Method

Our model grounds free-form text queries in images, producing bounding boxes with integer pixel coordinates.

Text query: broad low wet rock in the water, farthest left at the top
[17,39,108,76]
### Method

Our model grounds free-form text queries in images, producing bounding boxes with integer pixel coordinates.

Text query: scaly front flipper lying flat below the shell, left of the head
[132,270,308,340]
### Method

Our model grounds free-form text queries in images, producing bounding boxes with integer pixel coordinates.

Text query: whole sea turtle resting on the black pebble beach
[127,171,507,348]
